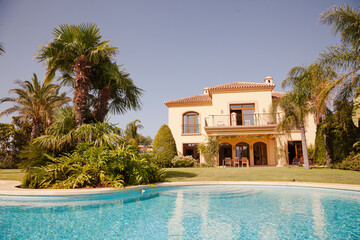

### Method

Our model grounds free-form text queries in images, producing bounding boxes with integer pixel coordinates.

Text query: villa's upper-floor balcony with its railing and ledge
[205,113,279,135]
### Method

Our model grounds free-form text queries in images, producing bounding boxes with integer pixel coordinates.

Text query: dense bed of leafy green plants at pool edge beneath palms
[23,144,163,188]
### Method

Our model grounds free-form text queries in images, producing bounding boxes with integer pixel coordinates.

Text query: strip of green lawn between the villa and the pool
[165,167,360,184]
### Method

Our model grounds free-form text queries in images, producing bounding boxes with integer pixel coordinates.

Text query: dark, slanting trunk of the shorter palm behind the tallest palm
[92,85,111,122]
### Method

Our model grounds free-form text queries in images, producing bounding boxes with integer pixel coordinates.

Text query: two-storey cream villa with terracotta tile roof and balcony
[165,77,316,166]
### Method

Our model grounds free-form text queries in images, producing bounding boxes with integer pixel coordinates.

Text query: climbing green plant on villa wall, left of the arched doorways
[198,136,219,167]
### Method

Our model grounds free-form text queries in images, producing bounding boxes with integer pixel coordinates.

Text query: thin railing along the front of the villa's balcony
[205,113,280,127]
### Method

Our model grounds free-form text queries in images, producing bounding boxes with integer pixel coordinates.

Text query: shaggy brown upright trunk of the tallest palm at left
[73,56,90,127]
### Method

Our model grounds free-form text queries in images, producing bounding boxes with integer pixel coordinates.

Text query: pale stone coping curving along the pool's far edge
[0,180,360,196]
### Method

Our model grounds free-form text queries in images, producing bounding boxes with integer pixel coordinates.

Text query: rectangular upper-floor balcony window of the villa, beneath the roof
[230,104,255,126]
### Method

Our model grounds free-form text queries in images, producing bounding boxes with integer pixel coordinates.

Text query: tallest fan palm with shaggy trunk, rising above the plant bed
[37,23,117,127]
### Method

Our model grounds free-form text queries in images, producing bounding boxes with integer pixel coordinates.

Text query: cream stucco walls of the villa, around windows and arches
[168,90,316,166]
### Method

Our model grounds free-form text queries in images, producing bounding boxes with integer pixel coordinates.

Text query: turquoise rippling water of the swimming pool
[0,185,360,239]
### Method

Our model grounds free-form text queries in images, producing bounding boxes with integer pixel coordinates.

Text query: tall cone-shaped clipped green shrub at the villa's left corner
[153,124,177,167]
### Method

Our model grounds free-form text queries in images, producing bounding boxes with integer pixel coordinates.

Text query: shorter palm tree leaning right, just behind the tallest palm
[92,61,143,122]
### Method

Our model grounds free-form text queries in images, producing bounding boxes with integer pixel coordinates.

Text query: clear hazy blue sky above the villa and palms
[0,0,359,137]
